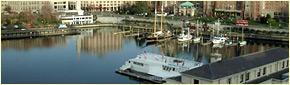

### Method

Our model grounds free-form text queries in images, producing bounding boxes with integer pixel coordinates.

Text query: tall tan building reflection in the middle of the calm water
[76,28,123,56]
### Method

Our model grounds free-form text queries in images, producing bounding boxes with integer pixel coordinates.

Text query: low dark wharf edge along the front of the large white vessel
[116,69,165,84]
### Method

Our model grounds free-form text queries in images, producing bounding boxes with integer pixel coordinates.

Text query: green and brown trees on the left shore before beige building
[1,4,60,28]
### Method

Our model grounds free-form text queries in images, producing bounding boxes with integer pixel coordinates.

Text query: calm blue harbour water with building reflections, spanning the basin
[1,28,288,84]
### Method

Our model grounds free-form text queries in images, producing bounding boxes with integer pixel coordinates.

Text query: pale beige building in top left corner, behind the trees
[1,0,50,13]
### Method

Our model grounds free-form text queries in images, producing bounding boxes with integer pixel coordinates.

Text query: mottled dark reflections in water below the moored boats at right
[153,40,289,63]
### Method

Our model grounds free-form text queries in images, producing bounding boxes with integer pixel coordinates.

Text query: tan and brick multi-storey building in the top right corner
[203,1,289,19]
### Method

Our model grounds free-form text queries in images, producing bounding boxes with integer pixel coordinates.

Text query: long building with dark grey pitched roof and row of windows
[181,48,289,84]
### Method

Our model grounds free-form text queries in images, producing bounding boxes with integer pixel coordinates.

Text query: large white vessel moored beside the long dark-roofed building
[120,53,203,79]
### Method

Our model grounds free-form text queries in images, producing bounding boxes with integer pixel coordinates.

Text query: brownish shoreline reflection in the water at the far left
[1,36,66,51]
